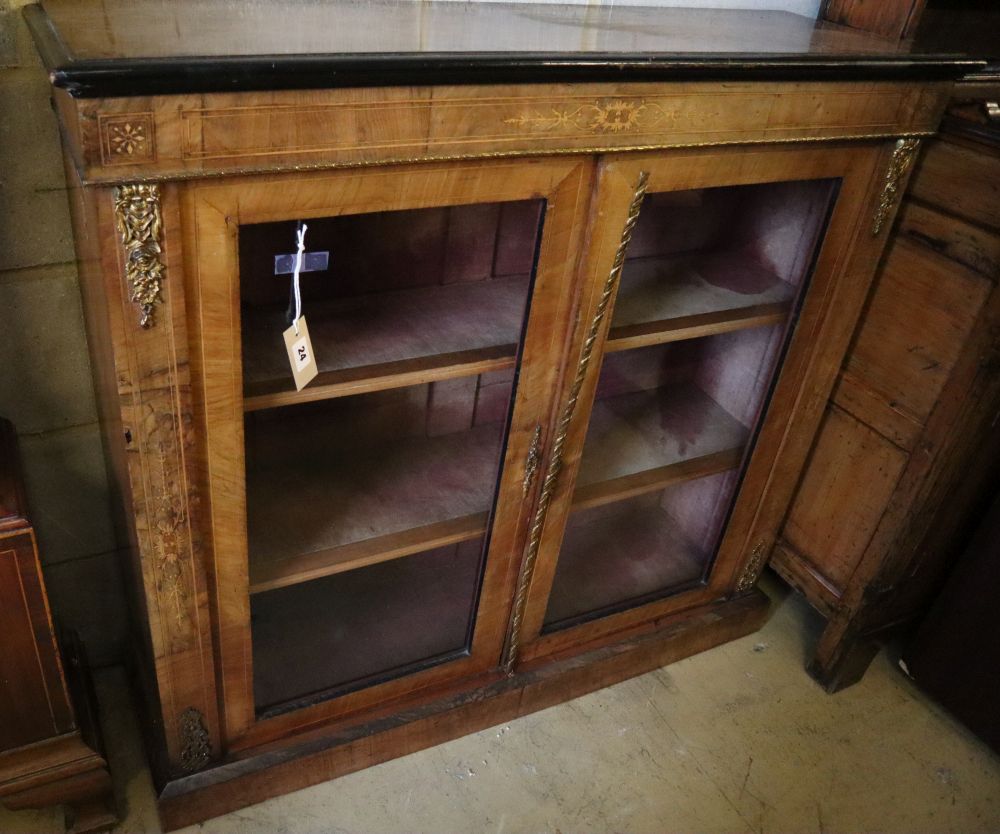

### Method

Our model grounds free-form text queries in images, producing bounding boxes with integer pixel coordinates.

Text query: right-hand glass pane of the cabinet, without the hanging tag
[543,180,837,632]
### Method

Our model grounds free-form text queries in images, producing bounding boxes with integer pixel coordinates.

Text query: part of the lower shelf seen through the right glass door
[573,383,749,509]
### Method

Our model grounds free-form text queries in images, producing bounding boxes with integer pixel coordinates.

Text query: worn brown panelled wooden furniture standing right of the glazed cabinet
[771,29,1000,691]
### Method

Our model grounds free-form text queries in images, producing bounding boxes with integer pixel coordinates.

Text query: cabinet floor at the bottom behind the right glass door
[545,499,708,628]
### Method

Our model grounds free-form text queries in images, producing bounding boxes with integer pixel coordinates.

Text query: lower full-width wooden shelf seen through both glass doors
[247,376,747,594]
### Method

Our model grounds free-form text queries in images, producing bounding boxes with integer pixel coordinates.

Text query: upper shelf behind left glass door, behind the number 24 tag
[242,277,529,411]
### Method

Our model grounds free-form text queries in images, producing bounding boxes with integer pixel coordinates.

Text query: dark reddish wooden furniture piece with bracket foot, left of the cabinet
[0,418,117,834]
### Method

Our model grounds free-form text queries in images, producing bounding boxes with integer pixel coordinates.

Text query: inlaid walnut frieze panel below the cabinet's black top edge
[57,82,946,182]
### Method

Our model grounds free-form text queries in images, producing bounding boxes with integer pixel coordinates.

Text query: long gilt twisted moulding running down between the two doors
[503,171,649,673]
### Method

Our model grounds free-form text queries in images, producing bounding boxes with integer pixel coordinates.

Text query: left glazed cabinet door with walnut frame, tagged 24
[184,159,593,750]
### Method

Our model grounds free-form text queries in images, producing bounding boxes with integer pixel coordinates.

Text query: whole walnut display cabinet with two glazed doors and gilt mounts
[26,0,968,828]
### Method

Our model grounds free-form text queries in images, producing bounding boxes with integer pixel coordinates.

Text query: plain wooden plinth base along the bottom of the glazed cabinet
[158,590,769,831]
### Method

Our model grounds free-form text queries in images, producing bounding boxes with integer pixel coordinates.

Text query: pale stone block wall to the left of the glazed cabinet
[0,0,126,665]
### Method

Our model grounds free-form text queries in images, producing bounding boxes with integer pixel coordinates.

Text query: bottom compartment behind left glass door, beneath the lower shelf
[250,536,484,714]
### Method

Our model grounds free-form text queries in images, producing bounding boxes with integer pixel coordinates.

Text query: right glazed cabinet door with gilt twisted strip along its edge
[507,144,887,665]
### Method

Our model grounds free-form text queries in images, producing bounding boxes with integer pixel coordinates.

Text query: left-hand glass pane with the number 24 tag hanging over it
[240,200,544,715]
